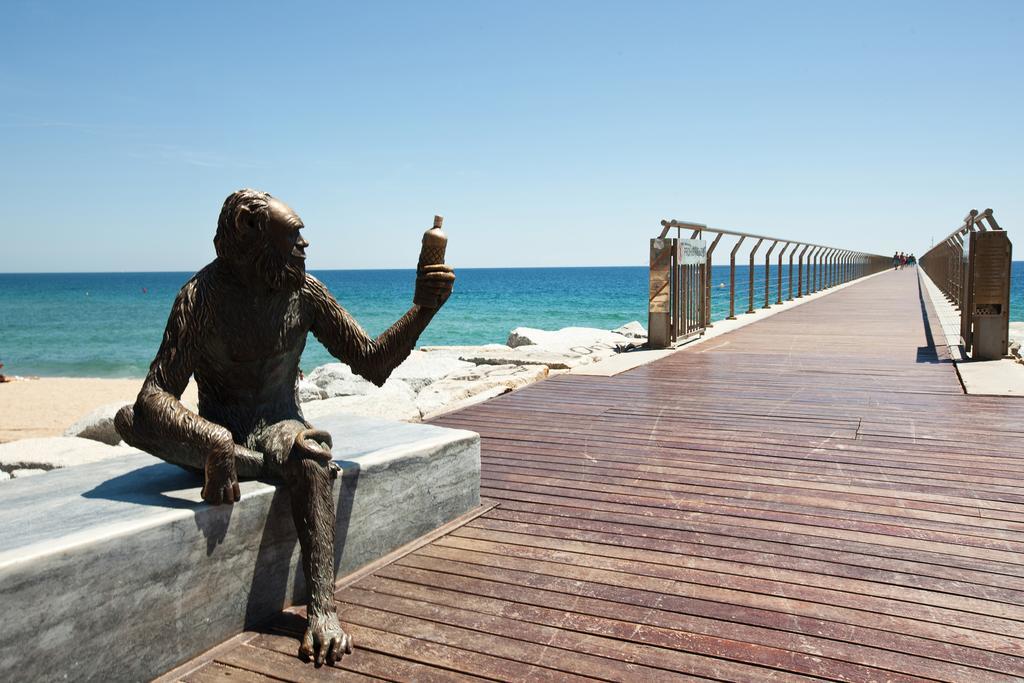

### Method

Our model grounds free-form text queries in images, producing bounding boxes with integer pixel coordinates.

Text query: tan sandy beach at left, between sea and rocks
[0,377,198,443]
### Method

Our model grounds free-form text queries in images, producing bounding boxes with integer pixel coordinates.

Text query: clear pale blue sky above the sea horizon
[0,0,1024,272]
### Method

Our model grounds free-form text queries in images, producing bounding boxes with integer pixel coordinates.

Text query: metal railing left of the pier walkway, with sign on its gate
[648,219,892,348]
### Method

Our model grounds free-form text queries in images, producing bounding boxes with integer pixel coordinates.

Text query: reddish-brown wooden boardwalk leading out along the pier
[174,271,1024,683]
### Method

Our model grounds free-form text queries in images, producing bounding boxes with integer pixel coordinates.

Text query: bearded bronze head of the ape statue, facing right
[213,189,309,290]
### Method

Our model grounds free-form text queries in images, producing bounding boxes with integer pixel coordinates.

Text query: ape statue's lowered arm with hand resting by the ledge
[134,280,239,503]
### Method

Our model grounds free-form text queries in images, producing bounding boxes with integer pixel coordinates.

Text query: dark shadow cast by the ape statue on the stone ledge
[82,460,360,628]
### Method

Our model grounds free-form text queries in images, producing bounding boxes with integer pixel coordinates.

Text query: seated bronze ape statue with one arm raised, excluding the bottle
[115,189,455,665]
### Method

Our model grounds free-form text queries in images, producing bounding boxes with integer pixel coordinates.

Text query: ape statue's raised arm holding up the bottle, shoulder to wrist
[306,275,437,386]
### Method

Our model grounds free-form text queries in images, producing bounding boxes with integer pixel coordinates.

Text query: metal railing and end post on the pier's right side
[918,209,1013,359]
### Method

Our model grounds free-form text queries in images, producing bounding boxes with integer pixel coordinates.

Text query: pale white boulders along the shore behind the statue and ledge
[0,322,647,480]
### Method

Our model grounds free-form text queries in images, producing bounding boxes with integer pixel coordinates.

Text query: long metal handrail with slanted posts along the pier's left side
[648,218,891,346]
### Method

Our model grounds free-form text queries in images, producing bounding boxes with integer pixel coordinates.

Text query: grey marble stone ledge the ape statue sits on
[0,415,480,680]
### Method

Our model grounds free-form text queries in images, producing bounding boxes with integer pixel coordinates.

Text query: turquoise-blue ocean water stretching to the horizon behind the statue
[0,261,1024,377]
